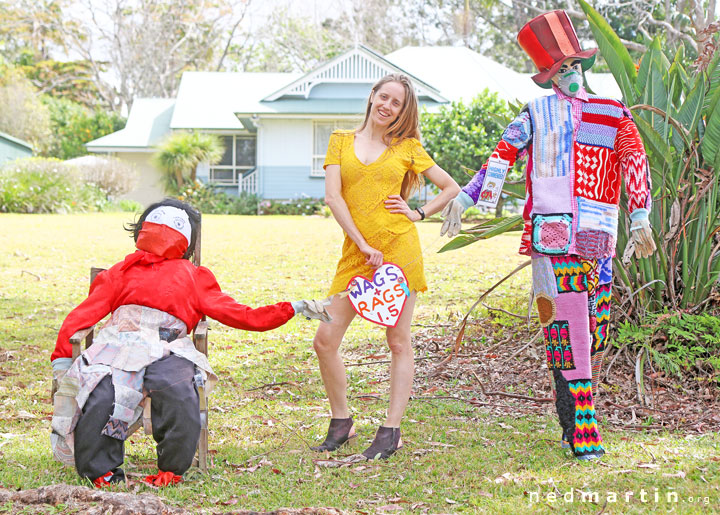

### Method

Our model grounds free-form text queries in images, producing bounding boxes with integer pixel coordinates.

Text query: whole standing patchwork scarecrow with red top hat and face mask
[441,11,655,459]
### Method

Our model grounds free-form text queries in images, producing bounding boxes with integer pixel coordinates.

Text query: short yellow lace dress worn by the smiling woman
[324,130,435,295]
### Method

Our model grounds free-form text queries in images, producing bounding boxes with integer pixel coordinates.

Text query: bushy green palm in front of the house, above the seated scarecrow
[153,131,225,192]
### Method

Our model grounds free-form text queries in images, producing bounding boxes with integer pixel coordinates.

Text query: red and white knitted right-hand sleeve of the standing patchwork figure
[615,117,651,213]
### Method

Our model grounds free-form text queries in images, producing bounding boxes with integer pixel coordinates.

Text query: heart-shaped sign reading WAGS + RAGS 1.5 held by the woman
[347,263,410,327]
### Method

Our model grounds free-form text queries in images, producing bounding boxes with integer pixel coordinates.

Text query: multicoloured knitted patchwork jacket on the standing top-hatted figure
[463,89,650,258]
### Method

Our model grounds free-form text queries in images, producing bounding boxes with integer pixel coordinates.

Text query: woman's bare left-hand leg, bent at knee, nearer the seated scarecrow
[313,295,355,422]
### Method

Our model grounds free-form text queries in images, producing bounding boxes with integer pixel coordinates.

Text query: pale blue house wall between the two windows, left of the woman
[258,119,325,199]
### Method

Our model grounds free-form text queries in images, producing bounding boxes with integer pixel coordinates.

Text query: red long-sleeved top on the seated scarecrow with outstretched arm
[50,250,295,360]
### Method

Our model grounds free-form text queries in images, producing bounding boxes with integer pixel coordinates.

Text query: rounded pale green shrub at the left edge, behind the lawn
[0,157,107,213]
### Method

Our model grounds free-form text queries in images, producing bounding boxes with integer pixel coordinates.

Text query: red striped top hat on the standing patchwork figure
[518,11,597,88]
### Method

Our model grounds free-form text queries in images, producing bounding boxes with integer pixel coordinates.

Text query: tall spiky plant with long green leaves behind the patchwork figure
[441,0,720,320]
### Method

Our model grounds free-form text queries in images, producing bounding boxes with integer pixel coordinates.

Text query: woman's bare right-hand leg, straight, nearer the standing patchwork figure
[385,291,417,427]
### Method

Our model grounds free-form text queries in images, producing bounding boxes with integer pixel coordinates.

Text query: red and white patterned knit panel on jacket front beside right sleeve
[575,143,620,205]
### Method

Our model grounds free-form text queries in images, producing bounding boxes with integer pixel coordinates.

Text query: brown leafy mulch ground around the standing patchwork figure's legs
[351,323,720,433]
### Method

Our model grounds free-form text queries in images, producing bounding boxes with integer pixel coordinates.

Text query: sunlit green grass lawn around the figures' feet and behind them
[0,213,720,513]
